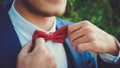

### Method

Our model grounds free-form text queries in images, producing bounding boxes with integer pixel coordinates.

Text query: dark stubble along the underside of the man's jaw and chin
[21,0,65,17]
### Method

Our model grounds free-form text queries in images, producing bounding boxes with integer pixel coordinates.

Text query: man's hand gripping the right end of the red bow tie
[68,21,118,55]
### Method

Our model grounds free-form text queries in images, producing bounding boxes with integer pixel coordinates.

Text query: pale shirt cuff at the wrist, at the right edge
[99,38,120,64]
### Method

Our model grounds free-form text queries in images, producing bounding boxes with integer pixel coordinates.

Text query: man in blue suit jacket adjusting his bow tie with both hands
[0,0,118,68]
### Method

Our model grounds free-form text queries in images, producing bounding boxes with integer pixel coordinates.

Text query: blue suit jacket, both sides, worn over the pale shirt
[0,0,97,68]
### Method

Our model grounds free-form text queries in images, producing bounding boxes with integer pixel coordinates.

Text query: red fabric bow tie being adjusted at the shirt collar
[32,25,68,43]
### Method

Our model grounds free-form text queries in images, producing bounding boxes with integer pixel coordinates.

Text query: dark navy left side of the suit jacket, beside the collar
[0,7,21,68]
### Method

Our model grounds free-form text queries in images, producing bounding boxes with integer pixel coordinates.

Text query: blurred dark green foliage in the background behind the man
[0,0,120,40]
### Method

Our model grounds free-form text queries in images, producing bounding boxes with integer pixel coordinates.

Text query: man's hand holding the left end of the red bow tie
[17,38,56,68]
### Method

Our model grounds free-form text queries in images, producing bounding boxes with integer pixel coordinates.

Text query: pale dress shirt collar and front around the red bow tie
[8,2,68,68]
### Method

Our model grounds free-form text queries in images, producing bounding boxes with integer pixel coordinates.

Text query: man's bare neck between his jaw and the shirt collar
[14,0,55,31]
